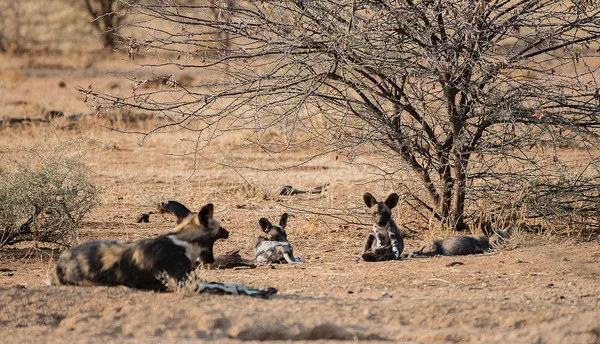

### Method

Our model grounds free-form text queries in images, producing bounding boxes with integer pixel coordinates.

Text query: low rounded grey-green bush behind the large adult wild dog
[0,150,99,247]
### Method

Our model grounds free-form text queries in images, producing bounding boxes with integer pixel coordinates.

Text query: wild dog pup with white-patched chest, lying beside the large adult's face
[254,213,301,264]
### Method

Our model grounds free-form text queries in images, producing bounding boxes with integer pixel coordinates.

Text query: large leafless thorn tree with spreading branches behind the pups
[82,0,600,234]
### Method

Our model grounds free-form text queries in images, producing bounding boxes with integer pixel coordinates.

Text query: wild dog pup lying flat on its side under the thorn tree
[412,231,509,257]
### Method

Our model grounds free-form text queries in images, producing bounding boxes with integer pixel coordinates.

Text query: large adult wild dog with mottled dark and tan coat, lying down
[50,201,229,291]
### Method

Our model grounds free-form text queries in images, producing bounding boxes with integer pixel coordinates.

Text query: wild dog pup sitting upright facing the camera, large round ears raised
[362,192,404,261]
